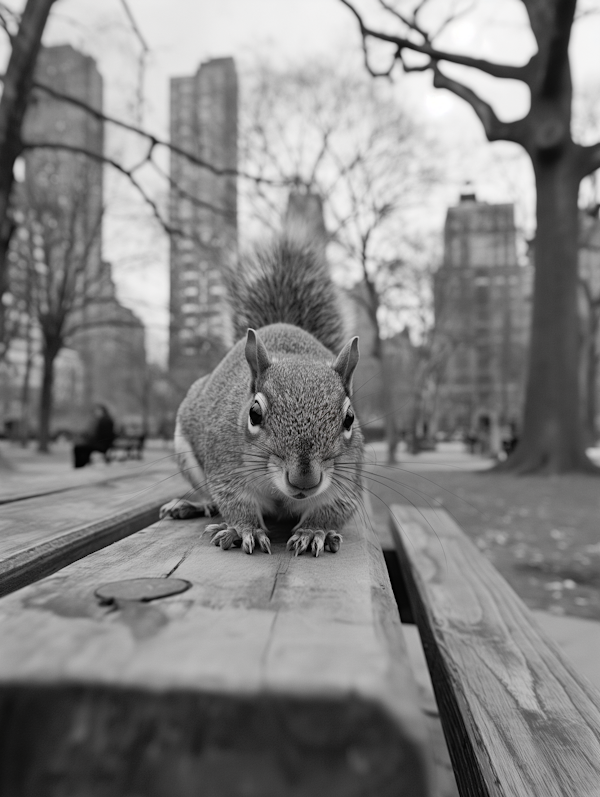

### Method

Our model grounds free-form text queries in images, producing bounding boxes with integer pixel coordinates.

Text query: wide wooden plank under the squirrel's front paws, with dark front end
[0,510,431,797]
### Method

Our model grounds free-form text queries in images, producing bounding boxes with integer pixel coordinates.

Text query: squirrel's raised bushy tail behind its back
[227,230,345,352]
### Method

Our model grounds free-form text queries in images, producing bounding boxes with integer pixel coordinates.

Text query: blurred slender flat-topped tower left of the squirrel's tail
[169,58,238,391]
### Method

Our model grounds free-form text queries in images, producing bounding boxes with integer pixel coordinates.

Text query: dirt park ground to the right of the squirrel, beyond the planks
[367,461,600,620]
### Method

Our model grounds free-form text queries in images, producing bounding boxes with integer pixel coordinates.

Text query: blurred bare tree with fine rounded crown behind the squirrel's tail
[241,63,435,461]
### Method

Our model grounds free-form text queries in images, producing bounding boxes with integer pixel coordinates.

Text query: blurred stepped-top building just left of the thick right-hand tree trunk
[434,194,532,438]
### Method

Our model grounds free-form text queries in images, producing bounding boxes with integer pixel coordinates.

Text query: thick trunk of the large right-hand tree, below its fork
[500,146,594,473]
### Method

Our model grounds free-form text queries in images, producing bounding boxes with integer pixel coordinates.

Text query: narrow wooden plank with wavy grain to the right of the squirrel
[392,505,600,797]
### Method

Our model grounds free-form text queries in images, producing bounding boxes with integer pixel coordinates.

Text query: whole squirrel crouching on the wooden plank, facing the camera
[160,230,363,556]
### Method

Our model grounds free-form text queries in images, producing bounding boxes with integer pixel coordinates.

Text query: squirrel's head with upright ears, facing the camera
[241,329,362,510]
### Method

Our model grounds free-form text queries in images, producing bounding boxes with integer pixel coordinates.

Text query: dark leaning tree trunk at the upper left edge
[0,0,54,358]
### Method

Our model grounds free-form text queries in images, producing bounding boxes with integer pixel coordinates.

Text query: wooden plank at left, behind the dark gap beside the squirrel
[0,473,190,595]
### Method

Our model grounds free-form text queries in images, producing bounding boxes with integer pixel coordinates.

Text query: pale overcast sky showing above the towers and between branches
[7,0,600,355]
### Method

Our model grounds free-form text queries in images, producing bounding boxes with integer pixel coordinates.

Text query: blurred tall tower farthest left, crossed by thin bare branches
[15,45,146,426]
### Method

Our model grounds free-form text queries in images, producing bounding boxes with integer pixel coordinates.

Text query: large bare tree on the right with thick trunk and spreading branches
[341,0,600,473]
